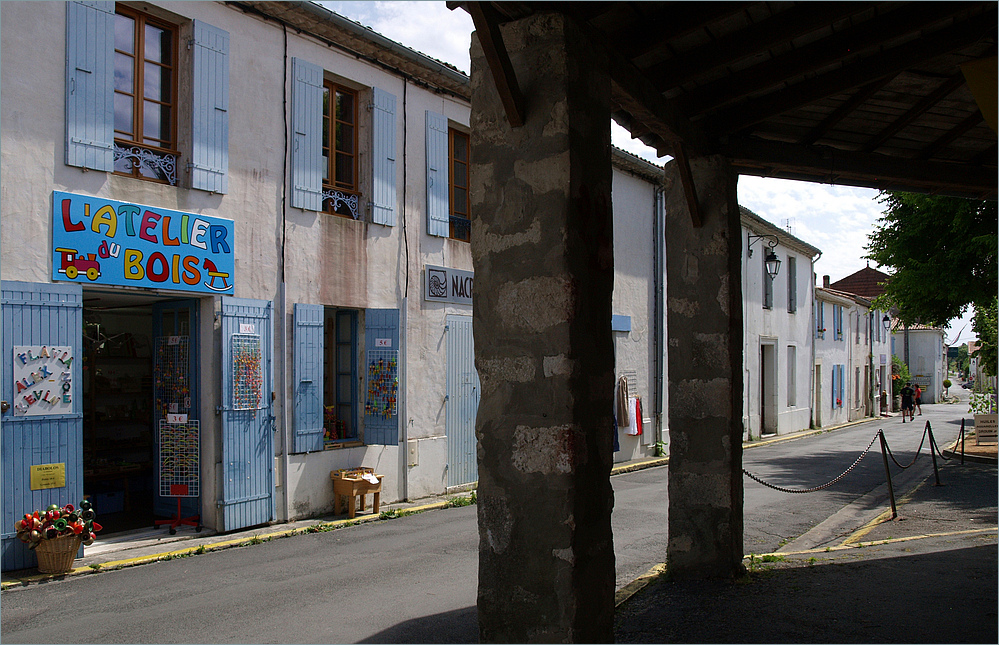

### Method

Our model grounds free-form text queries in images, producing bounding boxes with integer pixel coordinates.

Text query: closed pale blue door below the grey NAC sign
[444,315,479,486]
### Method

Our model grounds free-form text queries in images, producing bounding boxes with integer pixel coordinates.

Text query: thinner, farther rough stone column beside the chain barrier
[666,157,744,578]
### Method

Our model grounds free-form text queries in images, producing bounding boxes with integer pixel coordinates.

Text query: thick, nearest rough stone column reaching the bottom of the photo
[471,14,614,643]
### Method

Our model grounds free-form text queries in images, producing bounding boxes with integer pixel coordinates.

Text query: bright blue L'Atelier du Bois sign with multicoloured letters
[52,191,235,295]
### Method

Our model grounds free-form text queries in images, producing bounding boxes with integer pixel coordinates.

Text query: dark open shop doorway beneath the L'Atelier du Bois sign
[82,292,200,535]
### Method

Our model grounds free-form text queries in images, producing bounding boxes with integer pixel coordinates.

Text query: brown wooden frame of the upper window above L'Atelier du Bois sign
[114,5,180,184]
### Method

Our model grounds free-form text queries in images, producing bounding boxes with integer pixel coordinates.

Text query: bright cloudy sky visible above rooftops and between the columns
[318,1,975,342]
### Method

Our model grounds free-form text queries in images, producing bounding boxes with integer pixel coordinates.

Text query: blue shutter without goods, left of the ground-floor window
[293,304,325,452]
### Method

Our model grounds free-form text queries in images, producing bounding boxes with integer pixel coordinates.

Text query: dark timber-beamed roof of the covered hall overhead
[456,1,999,199]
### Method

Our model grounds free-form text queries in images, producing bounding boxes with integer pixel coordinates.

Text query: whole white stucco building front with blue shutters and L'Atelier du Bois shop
[0,2,667,569]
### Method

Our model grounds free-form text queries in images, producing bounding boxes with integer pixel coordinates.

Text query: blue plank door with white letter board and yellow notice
[0,281,83,571]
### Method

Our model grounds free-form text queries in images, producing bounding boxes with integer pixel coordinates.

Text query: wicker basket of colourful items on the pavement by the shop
[14,500,102,573]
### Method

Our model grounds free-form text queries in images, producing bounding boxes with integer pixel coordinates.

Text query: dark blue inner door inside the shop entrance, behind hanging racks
[153,299,201,517]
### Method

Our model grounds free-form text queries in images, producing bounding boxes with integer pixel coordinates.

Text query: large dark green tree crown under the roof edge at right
[865,192,999,322]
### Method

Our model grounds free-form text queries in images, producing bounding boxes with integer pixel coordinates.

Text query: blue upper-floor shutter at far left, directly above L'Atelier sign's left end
[66,2,115,172]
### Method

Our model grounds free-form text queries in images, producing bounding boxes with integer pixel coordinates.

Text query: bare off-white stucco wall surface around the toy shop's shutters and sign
[0,2,665,528]
